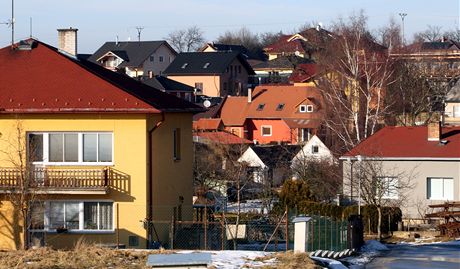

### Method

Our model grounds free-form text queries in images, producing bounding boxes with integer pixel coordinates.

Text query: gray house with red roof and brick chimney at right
[340,123,460,219]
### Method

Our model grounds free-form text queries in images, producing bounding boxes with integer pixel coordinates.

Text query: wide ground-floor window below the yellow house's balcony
[31,201,113,231]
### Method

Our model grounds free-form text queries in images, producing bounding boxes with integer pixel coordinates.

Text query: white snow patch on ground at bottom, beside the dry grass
[178,250,276,269]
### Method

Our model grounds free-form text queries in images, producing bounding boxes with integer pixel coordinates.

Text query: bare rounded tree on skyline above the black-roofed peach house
[165,26,204,52]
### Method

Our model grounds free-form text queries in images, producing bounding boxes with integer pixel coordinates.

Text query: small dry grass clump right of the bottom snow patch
[261,251,323,269]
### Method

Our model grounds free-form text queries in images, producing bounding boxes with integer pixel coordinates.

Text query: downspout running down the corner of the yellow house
[147,112,165,248]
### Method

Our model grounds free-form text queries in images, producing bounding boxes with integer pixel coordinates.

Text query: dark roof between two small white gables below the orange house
[251,145,301,168]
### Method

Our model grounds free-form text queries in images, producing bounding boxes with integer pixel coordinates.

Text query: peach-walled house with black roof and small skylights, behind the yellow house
[164,52,254,97]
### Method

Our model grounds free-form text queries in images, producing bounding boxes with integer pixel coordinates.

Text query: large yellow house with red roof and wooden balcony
[0,39,201,249]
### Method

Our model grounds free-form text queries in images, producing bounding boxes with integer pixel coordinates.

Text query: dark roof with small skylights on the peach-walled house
[163,51,254,75]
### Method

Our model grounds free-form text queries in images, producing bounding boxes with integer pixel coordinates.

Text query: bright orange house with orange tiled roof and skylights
[217,85,324,144]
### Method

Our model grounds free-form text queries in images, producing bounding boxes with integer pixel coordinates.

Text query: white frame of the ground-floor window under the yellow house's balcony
[30,200,116,234]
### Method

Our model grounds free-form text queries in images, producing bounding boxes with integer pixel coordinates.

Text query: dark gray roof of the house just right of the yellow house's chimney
[88,40,175,67]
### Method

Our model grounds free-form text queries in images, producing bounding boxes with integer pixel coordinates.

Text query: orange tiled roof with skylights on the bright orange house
[220,85,324,126]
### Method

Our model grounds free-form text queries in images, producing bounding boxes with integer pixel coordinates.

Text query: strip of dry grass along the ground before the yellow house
[0,238,172,269]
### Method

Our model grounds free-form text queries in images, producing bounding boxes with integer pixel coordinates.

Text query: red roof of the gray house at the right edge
[342,126,460,158]
